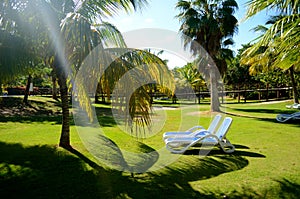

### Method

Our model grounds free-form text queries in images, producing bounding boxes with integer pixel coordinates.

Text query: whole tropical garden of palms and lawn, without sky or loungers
[0,0,300,198]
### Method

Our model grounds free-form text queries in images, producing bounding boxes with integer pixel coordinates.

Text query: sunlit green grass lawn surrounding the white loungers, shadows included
[0,97,300,198]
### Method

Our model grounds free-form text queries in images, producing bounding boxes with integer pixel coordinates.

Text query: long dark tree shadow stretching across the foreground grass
[0,142,300,199]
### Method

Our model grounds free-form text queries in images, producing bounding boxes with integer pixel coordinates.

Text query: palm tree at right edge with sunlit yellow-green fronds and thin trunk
[244,0,300,103]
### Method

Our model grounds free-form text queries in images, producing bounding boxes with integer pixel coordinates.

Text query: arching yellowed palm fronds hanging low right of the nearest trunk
[76,44,175,137]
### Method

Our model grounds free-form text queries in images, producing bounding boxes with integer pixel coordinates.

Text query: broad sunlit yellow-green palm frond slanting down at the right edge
[242,14,300,73]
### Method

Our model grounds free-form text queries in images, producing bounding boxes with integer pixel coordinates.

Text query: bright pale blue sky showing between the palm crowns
[109,0,268,67]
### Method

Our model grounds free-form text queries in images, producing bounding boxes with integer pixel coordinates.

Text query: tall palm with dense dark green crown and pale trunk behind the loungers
[176,0,238,111]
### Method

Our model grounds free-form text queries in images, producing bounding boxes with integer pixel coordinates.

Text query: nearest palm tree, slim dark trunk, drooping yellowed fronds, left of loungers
[2,0,173,148]
